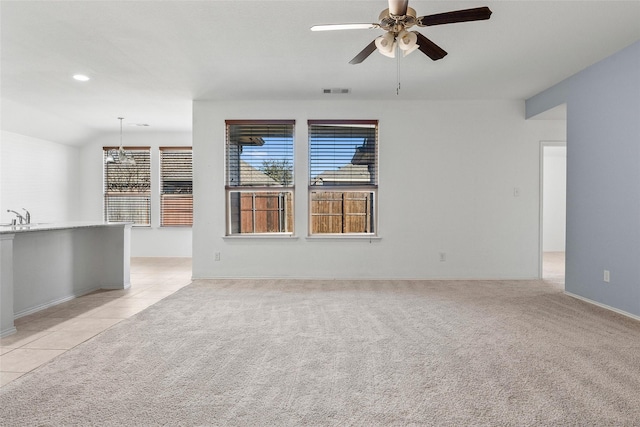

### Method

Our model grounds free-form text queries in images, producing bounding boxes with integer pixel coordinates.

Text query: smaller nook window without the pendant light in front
[160,147,193,227]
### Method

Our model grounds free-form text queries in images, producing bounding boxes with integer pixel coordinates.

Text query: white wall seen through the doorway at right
[542,144,567,252]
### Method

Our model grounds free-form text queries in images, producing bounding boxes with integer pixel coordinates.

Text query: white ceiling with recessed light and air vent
[0,0,640,144]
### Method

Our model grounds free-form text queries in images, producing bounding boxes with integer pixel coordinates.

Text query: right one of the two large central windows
[308,120,378,235]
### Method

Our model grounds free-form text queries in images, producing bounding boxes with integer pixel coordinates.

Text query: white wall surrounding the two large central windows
[193,101,565,279]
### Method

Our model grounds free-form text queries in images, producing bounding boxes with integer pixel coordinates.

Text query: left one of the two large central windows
[226,120,295,235]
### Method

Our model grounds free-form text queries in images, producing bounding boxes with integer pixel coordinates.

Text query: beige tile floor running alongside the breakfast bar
[0,258,191,387]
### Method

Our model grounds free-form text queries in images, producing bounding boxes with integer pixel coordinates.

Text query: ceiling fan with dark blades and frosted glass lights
[311,0,491,64]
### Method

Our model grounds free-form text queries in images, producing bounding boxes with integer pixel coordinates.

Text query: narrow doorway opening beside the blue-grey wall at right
[540,141,567,289]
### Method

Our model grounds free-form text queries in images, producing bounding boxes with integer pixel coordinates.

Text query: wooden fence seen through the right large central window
[311,191,373,234]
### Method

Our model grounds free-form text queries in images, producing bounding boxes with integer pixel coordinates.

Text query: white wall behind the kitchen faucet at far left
[0,131,82,223]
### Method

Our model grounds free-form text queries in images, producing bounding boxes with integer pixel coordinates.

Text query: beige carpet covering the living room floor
[0,280,640,426]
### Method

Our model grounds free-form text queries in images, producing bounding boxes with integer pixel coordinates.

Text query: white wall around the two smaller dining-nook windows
[80,128,192,257]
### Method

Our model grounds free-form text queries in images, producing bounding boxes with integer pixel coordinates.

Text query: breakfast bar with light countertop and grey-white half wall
[0,222,131,337]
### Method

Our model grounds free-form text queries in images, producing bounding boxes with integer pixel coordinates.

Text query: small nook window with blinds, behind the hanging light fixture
[103,147,151,226]
